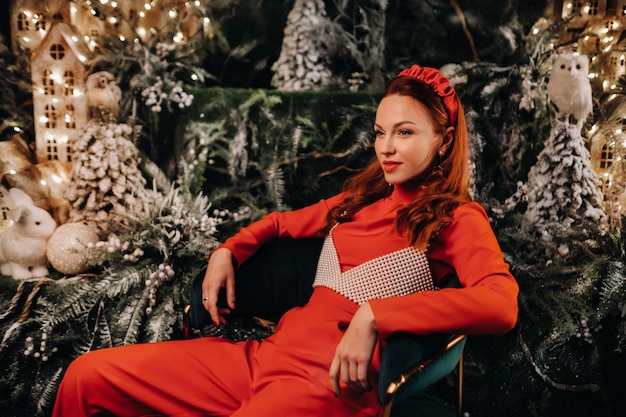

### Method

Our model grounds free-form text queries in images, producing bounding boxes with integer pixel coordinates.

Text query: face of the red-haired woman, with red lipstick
[374,94,452,185]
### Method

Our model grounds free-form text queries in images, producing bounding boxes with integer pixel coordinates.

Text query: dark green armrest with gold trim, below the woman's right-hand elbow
[378,333,466,405]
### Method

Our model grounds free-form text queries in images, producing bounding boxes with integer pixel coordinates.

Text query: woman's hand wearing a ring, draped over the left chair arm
[202,248,235,326]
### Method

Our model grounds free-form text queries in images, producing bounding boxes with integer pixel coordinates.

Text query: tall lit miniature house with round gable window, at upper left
[31,22,90,163]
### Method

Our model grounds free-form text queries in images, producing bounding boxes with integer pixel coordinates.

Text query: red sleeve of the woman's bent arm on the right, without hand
[369,203,519,338]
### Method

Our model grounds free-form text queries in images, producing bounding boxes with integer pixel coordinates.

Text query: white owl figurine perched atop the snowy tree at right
[548,53,593,131]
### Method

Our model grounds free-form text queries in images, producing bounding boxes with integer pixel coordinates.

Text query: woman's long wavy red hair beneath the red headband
[323,76,472,250]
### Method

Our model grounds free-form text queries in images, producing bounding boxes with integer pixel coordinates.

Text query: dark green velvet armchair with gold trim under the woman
[185,239,465,417]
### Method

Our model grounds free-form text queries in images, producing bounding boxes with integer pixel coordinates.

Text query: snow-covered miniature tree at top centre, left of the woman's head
[272,0,332,91]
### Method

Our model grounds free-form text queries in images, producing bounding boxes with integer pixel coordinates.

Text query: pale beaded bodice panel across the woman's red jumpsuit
[313,226,435,305]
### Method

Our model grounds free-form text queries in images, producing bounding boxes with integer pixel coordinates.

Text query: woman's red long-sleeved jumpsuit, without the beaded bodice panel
[53,191,518,417]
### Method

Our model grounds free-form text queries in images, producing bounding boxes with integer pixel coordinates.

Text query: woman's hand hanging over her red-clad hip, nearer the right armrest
[329,303,378,397]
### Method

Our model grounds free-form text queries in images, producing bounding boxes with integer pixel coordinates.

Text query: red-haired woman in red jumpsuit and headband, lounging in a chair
[53,65,518,417]
